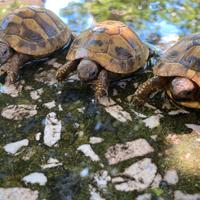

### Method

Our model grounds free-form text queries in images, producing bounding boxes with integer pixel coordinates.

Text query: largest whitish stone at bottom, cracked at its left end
[112,158,157,192]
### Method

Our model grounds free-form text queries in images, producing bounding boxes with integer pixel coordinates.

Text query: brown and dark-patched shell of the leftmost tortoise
[1,7,71,56]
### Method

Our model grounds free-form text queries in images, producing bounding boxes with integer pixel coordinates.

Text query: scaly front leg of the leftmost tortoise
[4,53,31,86]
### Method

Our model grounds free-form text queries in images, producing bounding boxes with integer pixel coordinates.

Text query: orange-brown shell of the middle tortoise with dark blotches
[66,20,149,74]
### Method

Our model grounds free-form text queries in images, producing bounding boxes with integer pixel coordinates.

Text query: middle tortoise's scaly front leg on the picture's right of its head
[94,70,109,100]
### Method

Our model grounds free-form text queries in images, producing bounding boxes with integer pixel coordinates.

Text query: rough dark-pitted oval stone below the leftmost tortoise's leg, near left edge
[1,104,37,120]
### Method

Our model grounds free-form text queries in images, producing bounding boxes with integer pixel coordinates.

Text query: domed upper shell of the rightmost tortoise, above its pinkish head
[153,34,200,86]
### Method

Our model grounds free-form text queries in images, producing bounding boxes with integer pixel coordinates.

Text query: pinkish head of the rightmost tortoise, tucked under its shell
[170,77,199,101]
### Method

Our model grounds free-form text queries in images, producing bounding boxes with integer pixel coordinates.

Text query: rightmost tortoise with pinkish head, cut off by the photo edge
[133,34,200,109]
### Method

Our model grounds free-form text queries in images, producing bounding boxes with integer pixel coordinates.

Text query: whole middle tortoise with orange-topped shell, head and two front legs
[56,20,150,99]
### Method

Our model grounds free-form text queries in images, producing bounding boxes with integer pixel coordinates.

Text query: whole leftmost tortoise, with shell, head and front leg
[0,7,73,85]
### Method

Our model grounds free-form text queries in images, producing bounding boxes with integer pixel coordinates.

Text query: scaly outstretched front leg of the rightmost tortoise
[129,76,168,105]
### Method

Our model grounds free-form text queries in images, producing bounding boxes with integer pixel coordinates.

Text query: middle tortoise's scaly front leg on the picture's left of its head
[56,60,78,81]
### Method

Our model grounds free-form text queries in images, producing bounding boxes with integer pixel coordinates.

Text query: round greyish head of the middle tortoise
[77,59,99,81]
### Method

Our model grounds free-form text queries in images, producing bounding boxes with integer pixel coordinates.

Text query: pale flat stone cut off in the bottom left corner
[0,187,39,200]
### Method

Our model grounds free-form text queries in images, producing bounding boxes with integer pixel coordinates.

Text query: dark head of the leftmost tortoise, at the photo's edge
[0,31,12,65]
